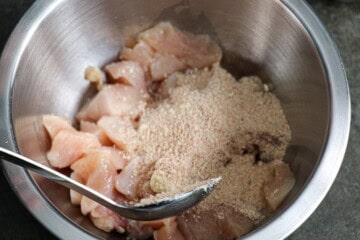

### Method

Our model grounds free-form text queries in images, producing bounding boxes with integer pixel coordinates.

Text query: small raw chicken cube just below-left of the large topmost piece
[105,61,147,94]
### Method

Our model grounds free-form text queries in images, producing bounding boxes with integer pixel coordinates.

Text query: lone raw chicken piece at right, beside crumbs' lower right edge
[264,163,295,210]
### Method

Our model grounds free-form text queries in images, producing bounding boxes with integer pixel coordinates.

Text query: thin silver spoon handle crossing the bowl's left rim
[0,147,125,210]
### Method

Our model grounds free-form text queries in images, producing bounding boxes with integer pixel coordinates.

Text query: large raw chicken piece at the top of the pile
[119,23,222,81]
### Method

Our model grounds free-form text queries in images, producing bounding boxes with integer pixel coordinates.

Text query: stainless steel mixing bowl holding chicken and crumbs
[0,0,350,239]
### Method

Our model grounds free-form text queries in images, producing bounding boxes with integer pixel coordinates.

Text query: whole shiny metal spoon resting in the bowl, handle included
[0,147,220,221]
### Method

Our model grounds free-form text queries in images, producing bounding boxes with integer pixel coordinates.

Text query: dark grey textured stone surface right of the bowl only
[289,0,360,240]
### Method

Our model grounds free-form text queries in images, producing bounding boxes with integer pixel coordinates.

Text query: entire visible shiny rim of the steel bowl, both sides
[0,0,351,240]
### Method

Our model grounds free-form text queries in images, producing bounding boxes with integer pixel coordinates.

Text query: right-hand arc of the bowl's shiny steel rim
[246,0,351,240]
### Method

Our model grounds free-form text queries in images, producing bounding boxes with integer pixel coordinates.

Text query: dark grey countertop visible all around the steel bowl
[0,0,360,240]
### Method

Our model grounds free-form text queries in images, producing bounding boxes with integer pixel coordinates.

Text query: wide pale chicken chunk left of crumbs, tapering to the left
[76,84,146,121]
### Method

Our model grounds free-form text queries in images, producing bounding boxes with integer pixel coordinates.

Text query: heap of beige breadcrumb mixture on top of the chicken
[136,64,290,220]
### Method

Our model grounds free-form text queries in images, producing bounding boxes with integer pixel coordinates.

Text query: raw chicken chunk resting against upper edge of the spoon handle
[47,130,101,168]
